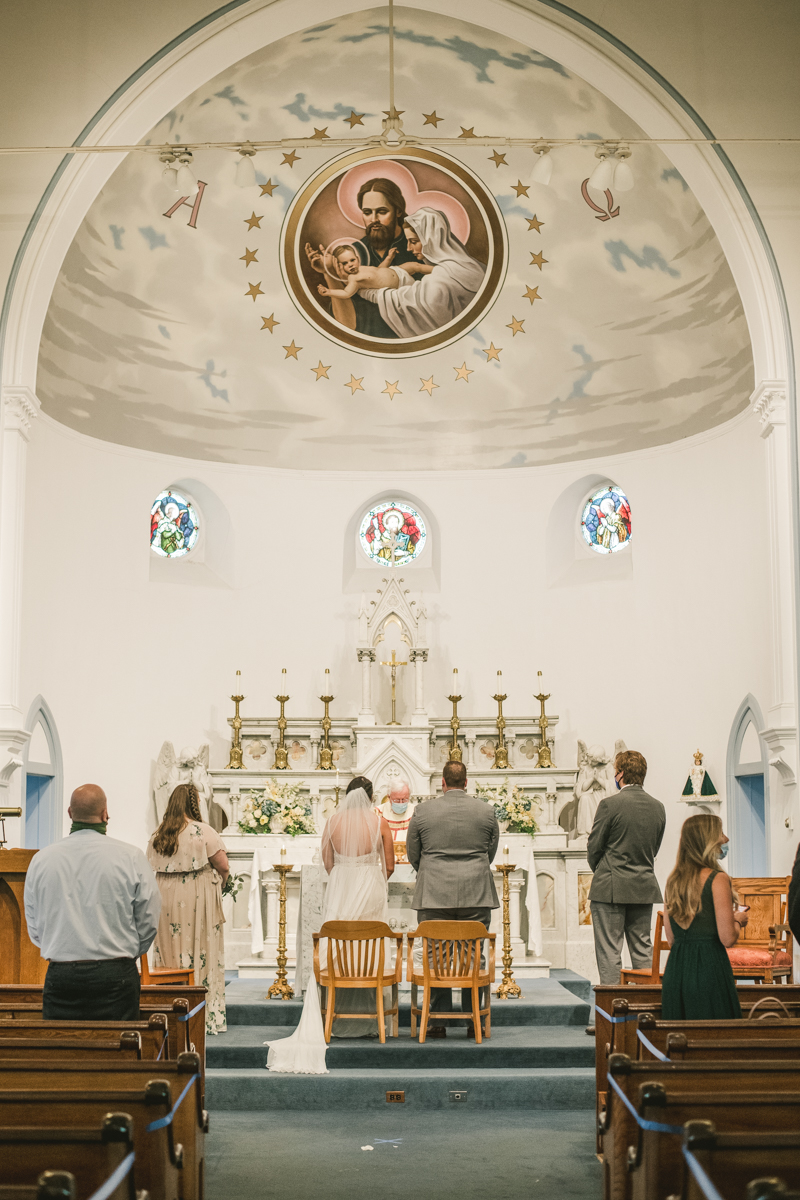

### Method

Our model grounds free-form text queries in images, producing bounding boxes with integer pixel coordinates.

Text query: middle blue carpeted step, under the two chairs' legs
[206,1025,595,1072]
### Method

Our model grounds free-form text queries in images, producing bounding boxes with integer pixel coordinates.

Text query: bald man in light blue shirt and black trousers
[25,784,161,1021]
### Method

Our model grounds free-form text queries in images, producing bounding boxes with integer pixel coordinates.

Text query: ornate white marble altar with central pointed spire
[210,576,595,978]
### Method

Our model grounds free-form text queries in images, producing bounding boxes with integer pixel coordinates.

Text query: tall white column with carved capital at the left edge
[0,386,40,830]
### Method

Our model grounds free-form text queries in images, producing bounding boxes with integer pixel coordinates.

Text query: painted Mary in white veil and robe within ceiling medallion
[361,209,486,337]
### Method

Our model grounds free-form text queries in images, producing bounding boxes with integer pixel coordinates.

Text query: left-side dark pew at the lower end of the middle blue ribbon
[0,1079,184,1200]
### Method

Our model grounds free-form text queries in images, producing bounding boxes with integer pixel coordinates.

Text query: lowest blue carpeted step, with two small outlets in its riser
[205,1067,595,1108]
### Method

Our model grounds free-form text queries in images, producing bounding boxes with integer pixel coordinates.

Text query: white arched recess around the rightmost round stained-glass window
[546,474,636,588]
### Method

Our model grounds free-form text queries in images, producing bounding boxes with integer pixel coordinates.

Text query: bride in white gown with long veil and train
[266,787,395,1075]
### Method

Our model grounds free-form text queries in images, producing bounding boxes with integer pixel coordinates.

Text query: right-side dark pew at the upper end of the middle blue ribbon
[602,1054,800,1200]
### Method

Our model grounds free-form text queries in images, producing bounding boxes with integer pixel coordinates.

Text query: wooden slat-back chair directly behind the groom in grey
[405,920,495,1045]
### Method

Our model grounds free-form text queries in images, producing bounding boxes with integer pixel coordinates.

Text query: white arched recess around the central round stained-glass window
[342,488,441,593]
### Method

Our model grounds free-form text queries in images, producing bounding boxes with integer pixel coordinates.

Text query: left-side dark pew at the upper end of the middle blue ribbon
[0,1052,209,1200]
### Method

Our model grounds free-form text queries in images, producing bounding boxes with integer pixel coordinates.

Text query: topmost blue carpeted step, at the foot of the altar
[225,972,590,1028]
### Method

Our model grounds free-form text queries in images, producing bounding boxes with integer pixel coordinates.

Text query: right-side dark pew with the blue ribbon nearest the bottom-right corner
[679,1121,800,1200]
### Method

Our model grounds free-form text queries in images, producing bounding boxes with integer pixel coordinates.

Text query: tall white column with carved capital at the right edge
[751,380,799,859]
